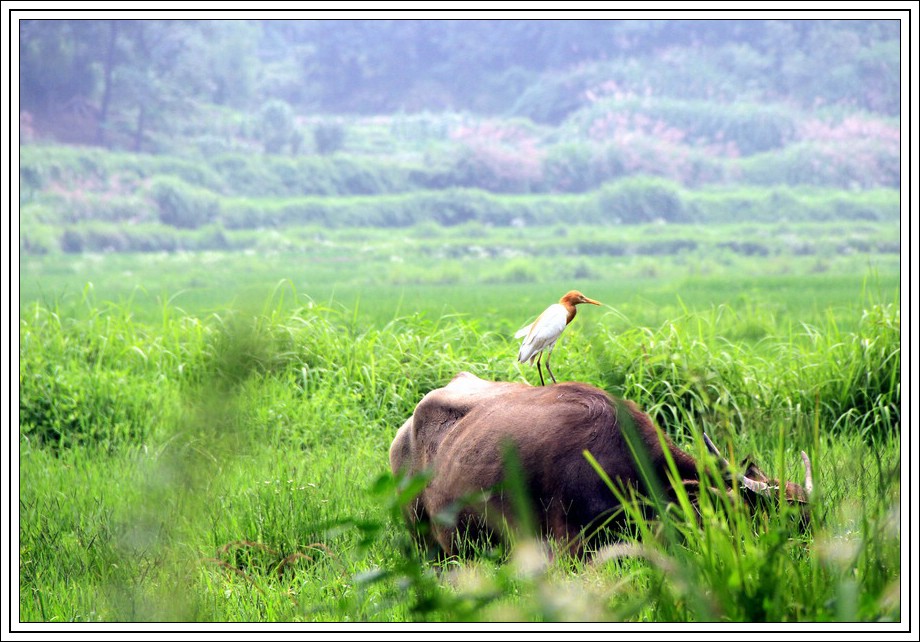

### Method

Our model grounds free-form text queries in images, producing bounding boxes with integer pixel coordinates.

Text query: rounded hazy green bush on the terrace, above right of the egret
[597,178,687,223]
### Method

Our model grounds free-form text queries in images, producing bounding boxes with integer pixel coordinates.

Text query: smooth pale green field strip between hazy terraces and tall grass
[19,224,900,334]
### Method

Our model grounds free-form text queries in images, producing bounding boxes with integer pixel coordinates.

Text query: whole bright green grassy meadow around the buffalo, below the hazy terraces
[18,222,904,626]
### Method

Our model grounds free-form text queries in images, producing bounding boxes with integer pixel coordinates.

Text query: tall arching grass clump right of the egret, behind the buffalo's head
[596,298,901,439]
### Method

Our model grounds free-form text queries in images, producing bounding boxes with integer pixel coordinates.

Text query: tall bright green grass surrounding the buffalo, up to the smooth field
[19,282,901,622]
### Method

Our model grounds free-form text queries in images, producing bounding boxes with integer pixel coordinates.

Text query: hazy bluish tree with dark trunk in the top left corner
[20,20,215,151]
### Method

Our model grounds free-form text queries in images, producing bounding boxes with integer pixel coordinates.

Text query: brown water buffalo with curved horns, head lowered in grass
[390,372,811,554]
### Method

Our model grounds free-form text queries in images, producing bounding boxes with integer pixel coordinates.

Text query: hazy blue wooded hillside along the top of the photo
[19,20,900,152]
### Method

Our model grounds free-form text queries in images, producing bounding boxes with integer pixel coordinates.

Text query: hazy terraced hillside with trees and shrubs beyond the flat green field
[19,20,901,248]
